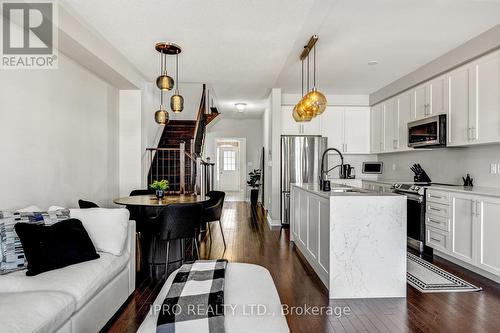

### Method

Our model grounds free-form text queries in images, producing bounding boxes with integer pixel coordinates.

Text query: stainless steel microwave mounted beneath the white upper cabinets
[408,114,446,148]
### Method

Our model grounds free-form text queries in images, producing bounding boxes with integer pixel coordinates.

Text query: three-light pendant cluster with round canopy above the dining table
[155,42,184,125]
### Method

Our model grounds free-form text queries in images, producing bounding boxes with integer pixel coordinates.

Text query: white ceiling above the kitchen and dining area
[64,0,500,115]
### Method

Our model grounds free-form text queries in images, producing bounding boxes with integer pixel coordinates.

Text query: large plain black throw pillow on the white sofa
[14,219,99,276]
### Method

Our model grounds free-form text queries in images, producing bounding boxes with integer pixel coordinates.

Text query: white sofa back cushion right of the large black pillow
[70,208,130,256]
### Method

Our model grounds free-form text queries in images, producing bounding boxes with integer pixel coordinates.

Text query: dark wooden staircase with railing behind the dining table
[147,85,219,193]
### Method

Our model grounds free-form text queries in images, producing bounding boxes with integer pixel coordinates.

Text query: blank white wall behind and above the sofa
[0,54,118,209]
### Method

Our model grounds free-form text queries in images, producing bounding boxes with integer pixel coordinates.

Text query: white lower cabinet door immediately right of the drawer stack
[451,193,477,264]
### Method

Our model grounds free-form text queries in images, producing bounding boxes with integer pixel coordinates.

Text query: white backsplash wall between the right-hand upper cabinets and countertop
[379,145,500,187]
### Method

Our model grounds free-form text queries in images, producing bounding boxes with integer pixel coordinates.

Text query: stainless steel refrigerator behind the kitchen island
[281,135,328,224]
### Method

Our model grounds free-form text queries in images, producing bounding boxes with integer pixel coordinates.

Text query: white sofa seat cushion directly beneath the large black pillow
[0,252,130,310]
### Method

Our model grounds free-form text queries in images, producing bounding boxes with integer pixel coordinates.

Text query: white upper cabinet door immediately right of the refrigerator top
[320,106,344,152]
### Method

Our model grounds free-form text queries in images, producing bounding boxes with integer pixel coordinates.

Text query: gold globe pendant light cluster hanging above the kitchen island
[292,35,327,122]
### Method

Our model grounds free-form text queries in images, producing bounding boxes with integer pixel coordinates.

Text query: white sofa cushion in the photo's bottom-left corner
[0,291,76,333]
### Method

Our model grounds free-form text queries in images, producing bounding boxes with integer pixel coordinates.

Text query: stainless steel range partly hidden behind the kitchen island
[391,183,431,253]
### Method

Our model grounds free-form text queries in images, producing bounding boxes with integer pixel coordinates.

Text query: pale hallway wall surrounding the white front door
[203,115,263,197]
